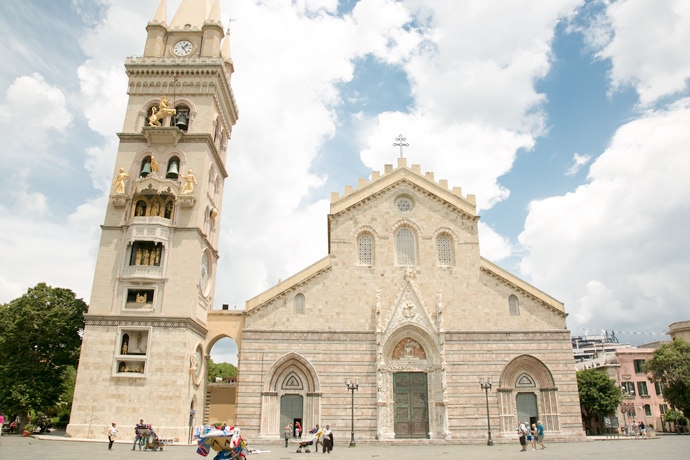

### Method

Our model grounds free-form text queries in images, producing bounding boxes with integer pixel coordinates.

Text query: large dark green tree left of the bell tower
[0,283,88,415]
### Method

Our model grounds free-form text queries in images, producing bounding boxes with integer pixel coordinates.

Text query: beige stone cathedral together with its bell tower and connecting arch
[67,0,584,442]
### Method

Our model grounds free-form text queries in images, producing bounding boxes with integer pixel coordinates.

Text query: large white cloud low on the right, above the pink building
[519,99,690,332]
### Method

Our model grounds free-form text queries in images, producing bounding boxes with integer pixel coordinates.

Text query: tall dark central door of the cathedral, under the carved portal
[393,372,429,438]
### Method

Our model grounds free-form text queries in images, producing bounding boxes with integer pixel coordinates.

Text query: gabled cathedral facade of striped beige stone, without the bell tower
[237,158,583,442]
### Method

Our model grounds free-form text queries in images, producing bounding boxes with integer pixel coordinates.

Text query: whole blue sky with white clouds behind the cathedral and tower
[0,0,690,362]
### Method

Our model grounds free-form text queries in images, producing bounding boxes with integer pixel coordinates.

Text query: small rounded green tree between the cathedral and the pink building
[577,369,621,425]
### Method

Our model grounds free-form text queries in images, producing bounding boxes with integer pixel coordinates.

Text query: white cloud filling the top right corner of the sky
[591,0,690,106]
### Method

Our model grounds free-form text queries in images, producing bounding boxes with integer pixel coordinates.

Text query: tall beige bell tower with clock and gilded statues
[67,0,238,441]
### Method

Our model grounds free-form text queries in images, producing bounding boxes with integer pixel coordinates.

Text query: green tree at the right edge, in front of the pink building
[643,337,690,417]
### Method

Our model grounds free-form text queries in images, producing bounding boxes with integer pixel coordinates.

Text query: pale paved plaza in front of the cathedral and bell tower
[0,435,690,460]
